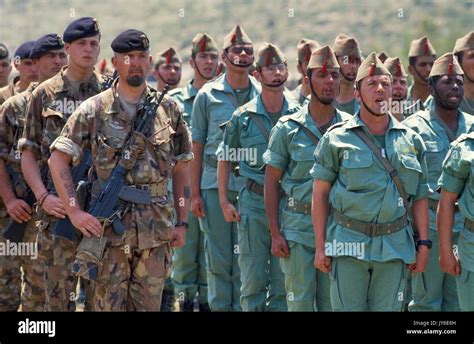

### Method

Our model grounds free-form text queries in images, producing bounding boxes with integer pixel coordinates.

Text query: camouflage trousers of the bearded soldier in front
[94,244,171,312]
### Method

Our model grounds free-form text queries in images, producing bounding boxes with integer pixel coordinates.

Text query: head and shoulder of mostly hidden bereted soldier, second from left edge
[0,41,38,105]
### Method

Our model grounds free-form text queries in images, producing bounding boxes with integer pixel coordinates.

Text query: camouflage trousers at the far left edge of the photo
[0,219,45,312]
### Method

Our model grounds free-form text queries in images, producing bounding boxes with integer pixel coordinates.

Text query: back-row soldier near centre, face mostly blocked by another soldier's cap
[291,38,320,105]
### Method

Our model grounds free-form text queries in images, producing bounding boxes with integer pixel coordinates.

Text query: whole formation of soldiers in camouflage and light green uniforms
[0,17,474,311]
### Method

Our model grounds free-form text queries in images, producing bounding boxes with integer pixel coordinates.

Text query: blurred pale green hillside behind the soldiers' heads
[0,0,474,83]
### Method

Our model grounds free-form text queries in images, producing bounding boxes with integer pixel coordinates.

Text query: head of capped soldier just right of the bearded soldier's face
[152,48,183,92]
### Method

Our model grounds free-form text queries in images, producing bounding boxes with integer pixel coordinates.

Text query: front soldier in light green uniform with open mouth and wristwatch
[311,53,430,311]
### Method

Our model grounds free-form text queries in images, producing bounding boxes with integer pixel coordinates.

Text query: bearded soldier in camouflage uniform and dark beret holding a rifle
[50,30,193,311]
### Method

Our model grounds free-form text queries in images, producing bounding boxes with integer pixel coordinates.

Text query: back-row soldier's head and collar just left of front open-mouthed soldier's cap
[333,33,362,115]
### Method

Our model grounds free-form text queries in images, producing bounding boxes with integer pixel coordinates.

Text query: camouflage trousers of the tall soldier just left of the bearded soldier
[38,220,94,312]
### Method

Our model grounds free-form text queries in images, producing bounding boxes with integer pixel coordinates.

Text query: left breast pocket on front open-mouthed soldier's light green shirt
[341,152,374,191]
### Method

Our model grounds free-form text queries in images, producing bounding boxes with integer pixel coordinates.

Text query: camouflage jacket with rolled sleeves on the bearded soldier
[51,81,193,249]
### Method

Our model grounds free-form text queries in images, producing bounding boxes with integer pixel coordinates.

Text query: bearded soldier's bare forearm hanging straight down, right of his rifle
[173,161,189,221]
